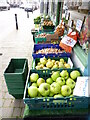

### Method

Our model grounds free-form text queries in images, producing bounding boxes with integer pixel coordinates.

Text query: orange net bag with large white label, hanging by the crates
[59,32,78,53]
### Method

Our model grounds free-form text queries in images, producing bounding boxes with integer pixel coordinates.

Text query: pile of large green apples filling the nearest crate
[28,70,81,98]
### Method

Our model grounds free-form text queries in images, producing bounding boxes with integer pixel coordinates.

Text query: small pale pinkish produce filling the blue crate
[36,47,64,54]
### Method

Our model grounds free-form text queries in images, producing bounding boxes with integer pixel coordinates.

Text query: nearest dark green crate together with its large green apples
[23,68,87,110]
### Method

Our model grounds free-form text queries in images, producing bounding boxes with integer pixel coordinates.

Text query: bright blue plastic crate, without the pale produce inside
[32,44,71,59]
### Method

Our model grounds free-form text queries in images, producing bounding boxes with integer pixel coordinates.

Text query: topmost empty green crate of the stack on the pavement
[4,58,28,84]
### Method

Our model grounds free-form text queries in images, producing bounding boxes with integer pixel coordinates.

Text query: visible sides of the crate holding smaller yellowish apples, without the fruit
[32,57,73,69]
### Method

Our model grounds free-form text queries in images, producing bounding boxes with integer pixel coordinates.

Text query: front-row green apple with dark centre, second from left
[38,83,50,97]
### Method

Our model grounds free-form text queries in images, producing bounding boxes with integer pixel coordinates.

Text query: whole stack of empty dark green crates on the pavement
[4,59,28,99]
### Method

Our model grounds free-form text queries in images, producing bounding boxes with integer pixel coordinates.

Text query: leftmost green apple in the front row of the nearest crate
[28,86,38,98]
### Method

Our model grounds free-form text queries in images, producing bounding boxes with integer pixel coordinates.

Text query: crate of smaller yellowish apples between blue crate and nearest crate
[32,57,73,70]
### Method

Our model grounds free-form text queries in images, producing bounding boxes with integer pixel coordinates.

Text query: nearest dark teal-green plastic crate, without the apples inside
[23,68,88,110]
